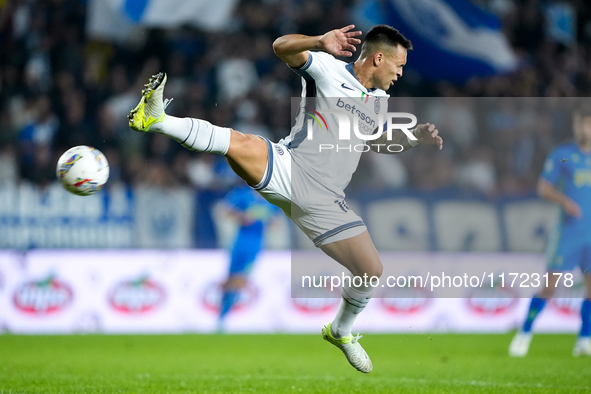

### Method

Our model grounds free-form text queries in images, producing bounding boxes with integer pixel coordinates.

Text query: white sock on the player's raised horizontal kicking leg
[150,115,232,155]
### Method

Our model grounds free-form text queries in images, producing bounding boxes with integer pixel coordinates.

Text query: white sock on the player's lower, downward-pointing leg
[330,281,375,339]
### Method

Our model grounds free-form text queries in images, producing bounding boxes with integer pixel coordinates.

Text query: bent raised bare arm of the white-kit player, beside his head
[273,25,361,68]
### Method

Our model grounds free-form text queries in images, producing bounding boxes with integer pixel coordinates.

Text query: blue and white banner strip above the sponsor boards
[0,183,558,253]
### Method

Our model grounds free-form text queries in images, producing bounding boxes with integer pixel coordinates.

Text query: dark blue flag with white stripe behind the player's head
[355,0,517,82]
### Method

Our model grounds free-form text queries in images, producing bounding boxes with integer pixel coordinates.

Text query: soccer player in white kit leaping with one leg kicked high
[129,25,443,373]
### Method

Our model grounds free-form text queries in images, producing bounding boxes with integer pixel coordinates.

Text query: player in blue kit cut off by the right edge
[509,108,591,357]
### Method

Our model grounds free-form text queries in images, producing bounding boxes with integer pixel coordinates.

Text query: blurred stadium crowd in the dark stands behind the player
[0,0,591,197]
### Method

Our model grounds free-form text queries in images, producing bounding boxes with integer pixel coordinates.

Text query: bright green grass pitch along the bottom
[0,334,591,394]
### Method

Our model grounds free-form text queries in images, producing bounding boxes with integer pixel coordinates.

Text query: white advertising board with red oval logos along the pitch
[0,250,582,333]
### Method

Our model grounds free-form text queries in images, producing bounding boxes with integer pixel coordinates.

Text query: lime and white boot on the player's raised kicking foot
[127,72,172,132]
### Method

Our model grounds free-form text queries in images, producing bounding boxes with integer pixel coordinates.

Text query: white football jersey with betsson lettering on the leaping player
[283,52,390,198]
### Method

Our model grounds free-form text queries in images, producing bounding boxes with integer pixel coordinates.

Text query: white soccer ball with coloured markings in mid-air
[56,145,109,196]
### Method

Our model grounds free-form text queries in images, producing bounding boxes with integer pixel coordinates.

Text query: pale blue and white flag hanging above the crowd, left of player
[86,0,238,40]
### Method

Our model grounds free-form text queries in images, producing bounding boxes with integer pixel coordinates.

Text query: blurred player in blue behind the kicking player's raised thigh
[218,186,279,331]
